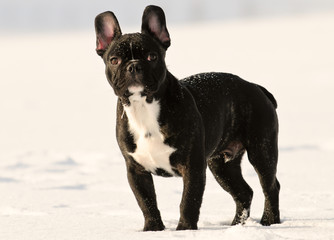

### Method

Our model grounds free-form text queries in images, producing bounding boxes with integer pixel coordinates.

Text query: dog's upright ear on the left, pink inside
[95,11,122,57]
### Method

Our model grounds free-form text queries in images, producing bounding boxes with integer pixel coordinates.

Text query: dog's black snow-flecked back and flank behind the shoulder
[180,72,278,157]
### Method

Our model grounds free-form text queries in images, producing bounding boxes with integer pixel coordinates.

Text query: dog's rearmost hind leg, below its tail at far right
[247,138,280,226]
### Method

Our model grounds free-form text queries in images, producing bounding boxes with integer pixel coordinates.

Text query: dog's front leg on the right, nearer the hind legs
[176,167,205,230]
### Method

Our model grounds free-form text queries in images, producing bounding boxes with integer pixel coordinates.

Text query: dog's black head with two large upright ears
[95,6,170,101]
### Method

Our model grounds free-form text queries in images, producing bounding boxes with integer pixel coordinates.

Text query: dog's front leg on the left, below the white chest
[127,161,165,231]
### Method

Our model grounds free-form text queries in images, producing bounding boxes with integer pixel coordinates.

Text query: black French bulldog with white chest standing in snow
[95,6,280,231]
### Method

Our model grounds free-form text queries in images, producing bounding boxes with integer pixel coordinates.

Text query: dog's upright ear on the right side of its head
[141,5,170,50]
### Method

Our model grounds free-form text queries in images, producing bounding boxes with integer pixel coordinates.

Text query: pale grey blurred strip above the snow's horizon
[0,0,334,31]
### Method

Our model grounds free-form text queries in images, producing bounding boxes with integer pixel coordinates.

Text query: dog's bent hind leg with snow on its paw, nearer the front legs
[208,153,253,225]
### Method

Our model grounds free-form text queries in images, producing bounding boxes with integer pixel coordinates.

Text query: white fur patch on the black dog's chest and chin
[124,86,176,175]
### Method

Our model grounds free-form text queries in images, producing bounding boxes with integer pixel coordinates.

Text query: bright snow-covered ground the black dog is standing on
[0,12,334,240]
